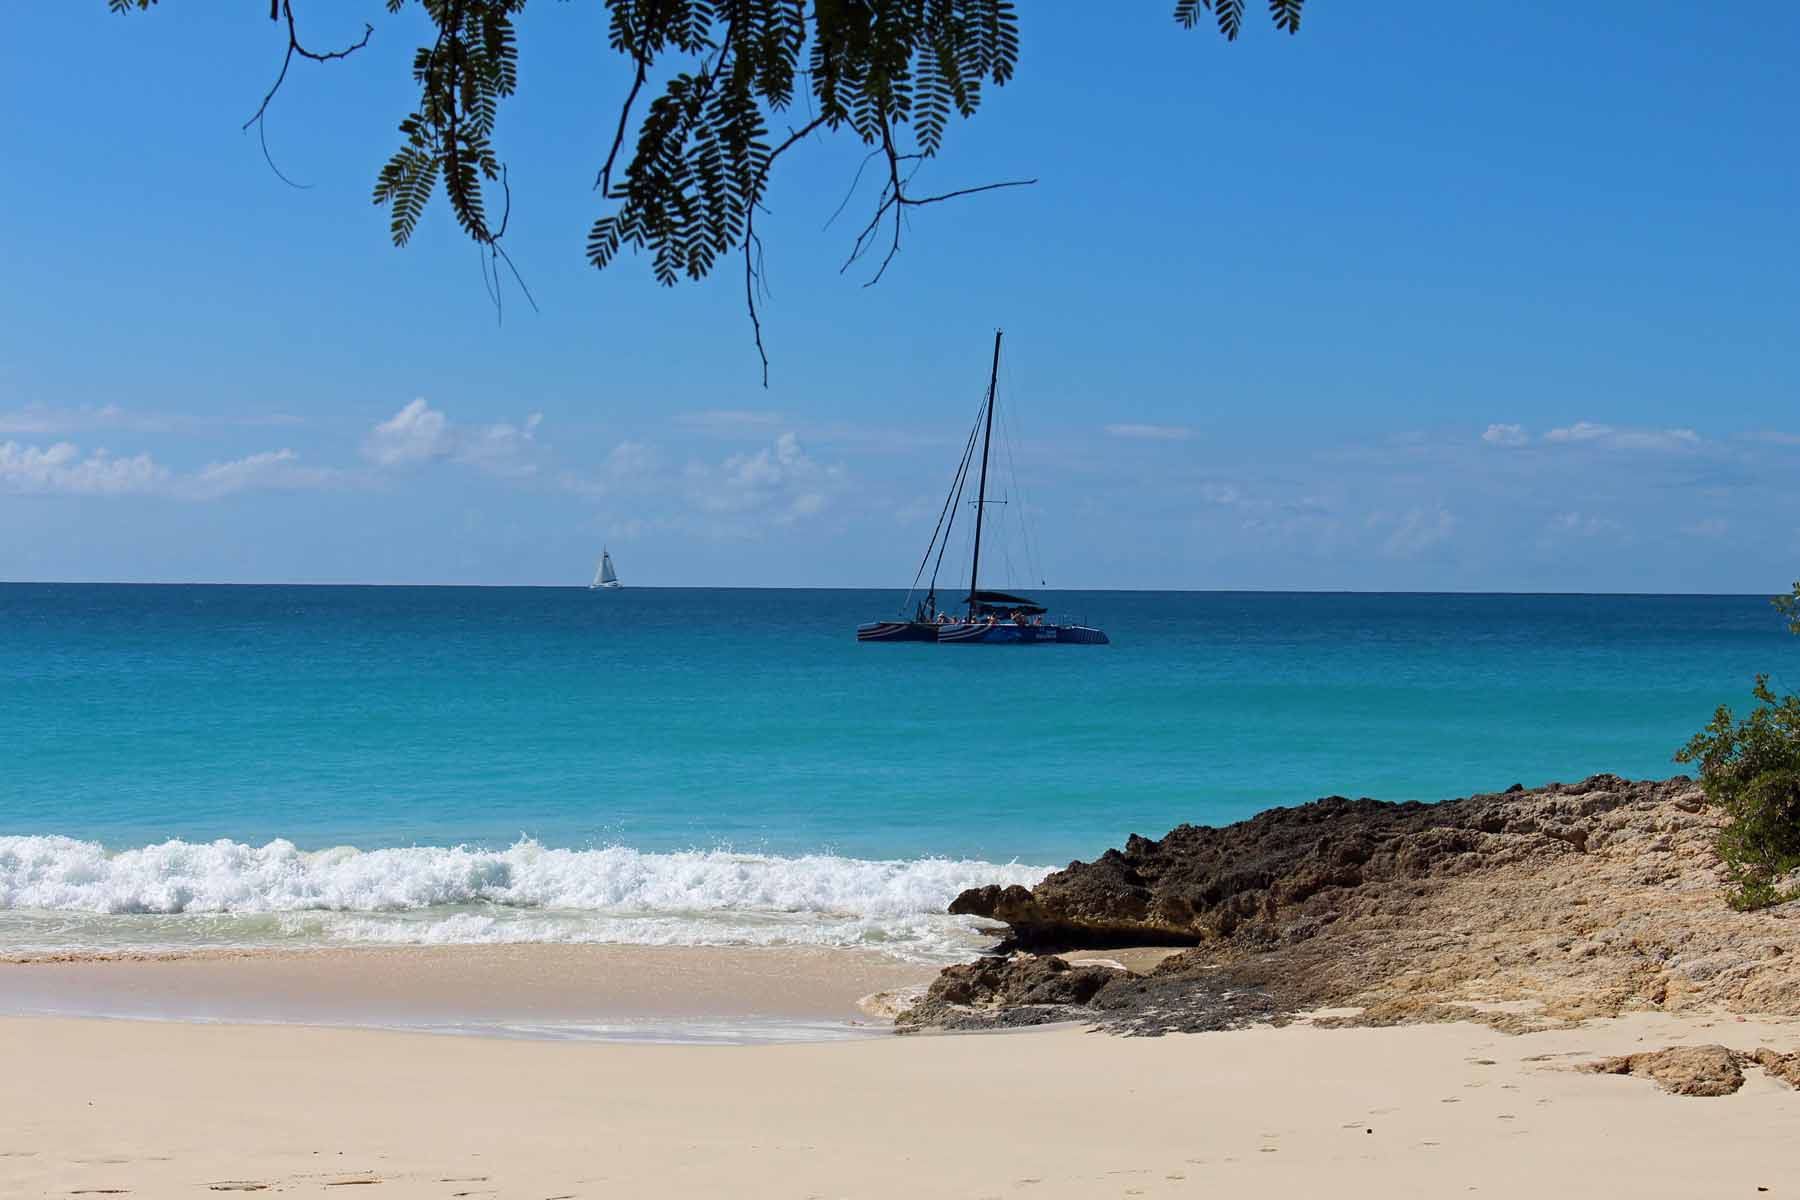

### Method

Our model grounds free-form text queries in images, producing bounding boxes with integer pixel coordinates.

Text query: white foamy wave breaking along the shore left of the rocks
[0,837,1048,957]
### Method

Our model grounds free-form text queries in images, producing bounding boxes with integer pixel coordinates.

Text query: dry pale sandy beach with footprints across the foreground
[0,1015,1800,1200]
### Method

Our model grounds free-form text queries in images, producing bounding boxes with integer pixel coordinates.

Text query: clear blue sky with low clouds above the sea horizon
[0,0,1800,592]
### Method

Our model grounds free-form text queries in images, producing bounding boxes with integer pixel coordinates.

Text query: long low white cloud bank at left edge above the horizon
[0,441,340,500]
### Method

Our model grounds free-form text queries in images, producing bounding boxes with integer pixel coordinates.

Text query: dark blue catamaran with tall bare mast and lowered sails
[857,329,1107,646]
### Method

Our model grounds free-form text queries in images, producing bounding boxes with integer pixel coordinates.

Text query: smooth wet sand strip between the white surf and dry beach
[0,945,936,1042]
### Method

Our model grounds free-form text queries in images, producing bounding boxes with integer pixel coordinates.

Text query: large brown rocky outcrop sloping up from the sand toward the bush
[907,775,1800,1033]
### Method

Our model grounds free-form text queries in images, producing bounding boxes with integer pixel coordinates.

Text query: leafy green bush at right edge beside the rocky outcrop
[1676,583,1800,909]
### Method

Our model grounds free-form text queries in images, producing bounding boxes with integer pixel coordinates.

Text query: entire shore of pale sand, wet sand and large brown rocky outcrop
[0,775,1800,1200]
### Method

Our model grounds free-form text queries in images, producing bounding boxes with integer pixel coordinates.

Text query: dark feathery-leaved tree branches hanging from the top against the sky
[108,0,1305,377]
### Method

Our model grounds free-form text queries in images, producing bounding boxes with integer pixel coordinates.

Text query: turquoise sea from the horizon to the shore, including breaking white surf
[0,585,1800,957]
